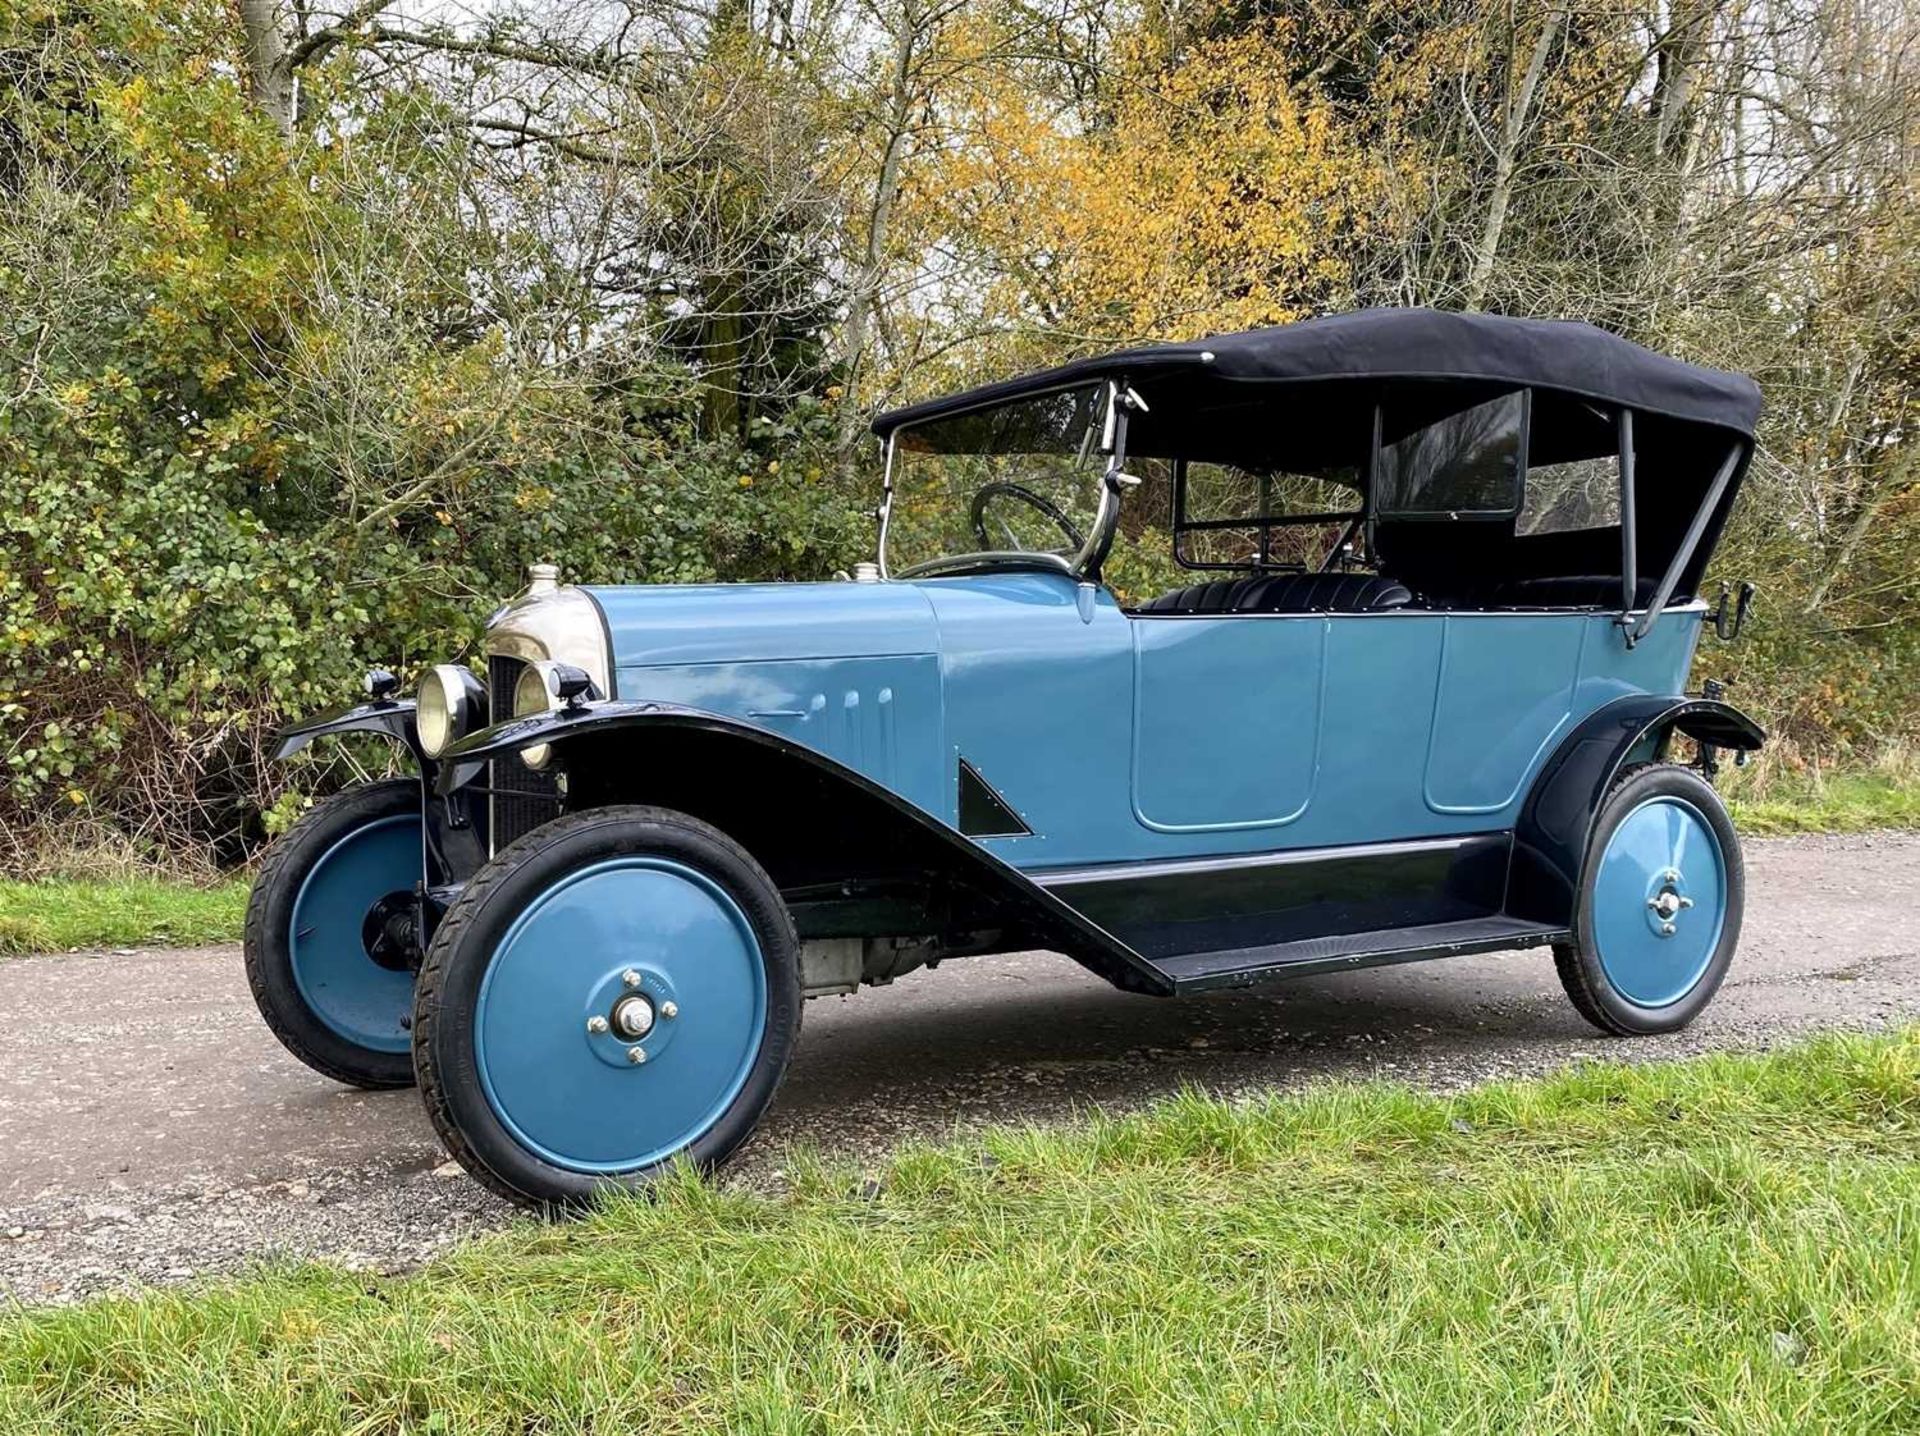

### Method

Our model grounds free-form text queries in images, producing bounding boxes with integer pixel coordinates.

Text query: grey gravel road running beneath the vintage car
[0,833,1920,1304]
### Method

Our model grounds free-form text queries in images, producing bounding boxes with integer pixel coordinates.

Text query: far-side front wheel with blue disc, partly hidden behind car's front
[246,778,422,1089]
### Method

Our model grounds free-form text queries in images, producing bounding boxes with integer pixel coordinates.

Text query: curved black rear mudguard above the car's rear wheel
[1507,693,1766,923]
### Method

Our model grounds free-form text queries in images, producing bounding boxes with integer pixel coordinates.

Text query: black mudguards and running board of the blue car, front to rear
[280,695,1764,996]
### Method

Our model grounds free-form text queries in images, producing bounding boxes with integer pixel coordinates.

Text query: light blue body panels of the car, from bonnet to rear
[588,572,1703,875]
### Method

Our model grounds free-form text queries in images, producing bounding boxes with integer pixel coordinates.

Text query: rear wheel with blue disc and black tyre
[1553,764,1747,1037]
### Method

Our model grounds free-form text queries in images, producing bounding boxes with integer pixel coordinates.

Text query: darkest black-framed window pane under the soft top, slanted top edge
[1375,390,1528,518]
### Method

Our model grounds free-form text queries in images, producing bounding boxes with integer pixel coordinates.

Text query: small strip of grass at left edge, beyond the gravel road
[0,877,248,952]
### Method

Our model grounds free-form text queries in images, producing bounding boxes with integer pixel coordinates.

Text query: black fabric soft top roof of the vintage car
[874,309,1761,442]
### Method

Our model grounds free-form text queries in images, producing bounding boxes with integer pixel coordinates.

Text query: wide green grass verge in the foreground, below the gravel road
[0,1031,1920,1432]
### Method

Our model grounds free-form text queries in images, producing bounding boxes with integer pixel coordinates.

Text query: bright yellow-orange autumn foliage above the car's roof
[916,19,1386,351]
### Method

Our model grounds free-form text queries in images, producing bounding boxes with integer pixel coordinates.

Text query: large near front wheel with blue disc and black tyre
[413,806,803,1206]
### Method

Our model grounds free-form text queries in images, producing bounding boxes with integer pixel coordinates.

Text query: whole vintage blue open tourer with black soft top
[246,309,1763,1204]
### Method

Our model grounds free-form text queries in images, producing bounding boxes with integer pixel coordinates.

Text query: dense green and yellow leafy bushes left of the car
[0,6,872,858]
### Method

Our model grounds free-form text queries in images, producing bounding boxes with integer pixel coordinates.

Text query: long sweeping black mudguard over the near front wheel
[438,699,1173,996]
